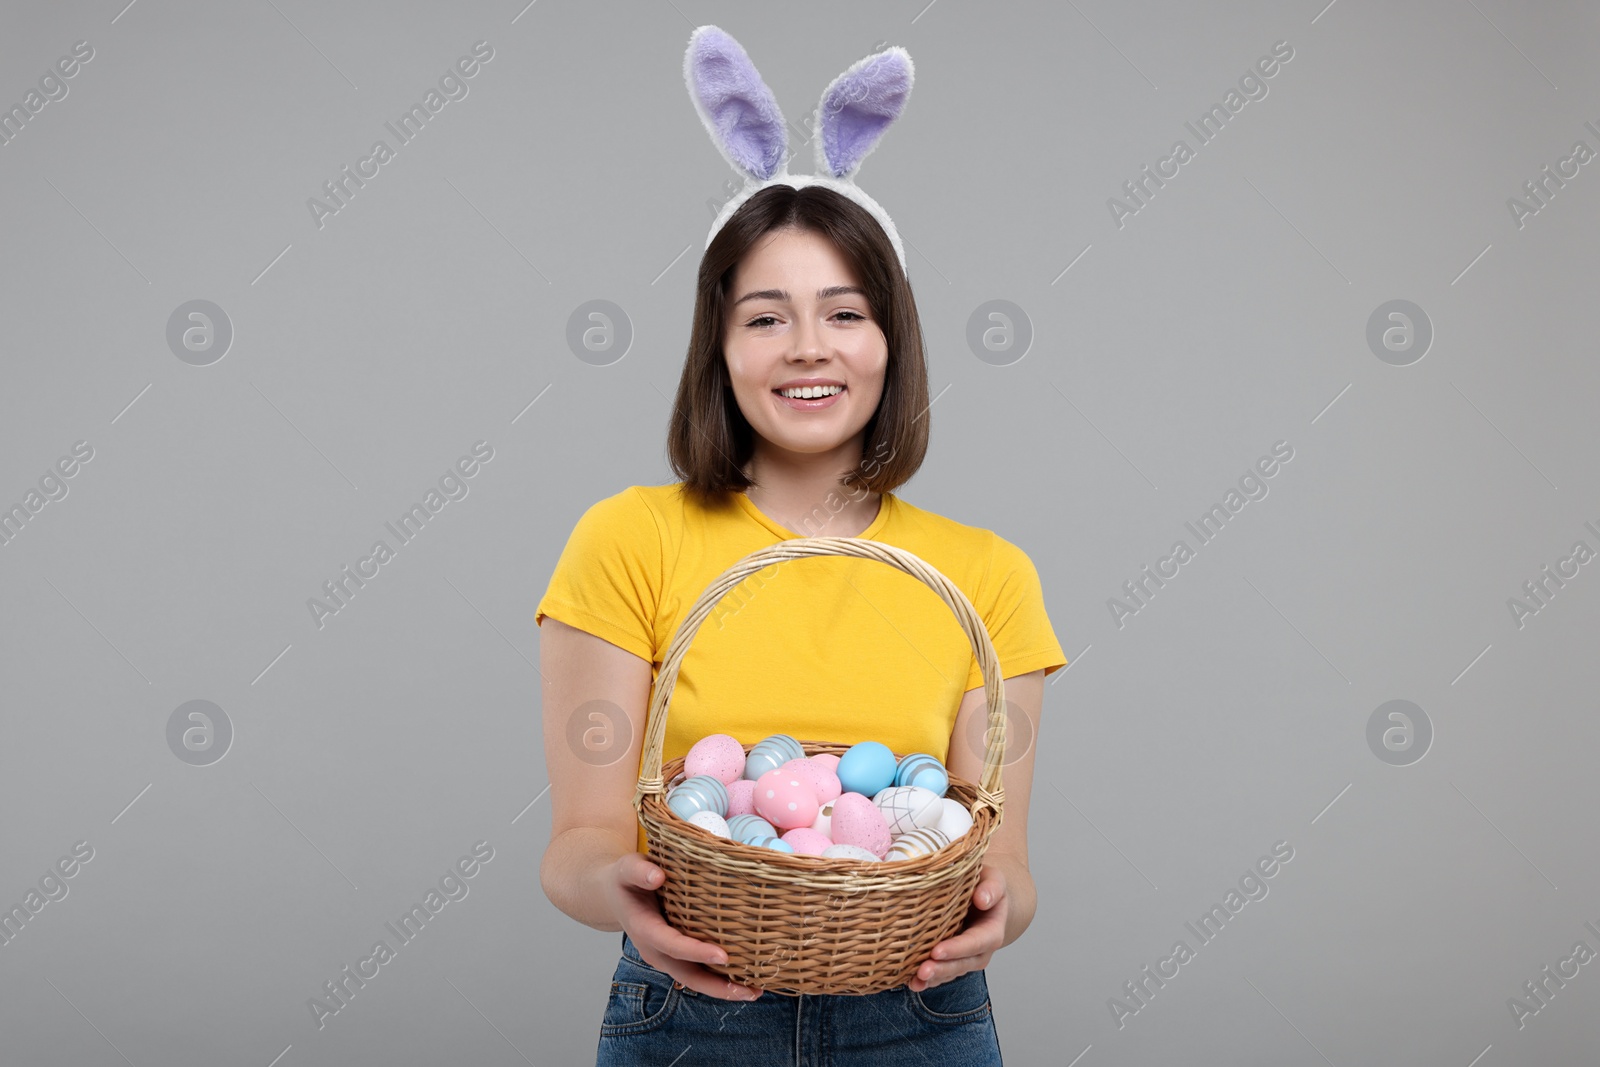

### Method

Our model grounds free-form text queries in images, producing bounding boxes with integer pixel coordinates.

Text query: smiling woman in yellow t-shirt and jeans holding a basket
[536,186,1067,1067]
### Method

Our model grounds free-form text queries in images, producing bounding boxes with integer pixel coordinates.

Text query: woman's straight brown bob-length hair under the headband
[667,184,931,504]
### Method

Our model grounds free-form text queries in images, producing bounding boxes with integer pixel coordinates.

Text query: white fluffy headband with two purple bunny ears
[683,26,912,270]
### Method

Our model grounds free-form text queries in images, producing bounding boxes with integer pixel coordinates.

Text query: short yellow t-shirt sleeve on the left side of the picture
[533,486,664,662]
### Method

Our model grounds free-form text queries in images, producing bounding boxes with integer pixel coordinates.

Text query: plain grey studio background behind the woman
[0,0,1600,1067]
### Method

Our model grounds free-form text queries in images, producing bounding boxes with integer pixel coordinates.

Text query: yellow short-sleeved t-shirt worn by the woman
[534,483,1067,853]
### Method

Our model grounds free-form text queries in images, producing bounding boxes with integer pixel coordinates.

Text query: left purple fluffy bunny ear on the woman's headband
[683,26,789,182]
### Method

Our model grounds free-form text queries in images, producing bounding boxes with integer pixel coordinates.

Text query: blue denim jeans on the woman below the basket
[595,933,1002,1067]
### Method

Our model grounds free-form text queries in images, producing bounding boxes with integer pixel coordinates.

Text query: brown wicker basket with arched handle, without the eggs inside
[634,537,1005,995]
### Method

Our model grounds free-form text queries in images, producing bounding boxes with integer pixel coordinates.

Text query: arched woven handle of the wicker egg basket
[634,537,1005,825]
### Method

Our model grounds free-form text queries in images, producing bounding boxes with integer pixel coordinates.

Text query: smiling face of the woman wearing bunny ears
[722,229,888,462]
